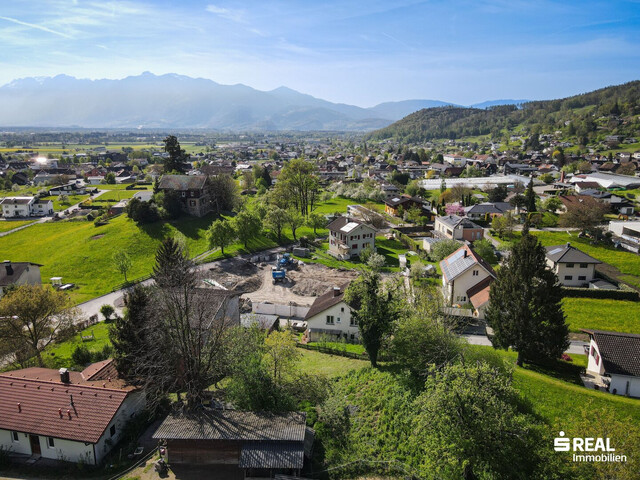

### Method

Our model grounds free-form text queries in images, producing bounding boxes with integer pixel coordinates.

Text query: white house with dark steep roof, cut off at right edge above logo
[583,330,640,397]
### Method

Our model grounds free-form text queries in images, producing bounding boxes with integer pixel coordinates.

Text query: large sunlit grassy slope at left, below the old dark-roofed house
[0,215,213,302]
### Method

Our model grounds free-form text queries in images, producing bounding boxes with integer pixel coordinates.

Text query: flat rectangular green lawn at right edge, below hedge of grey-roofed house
[562,298,640,333]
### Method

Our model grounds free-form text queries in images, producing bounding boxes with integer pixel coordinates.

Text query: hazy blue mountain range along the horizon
[0,72,525,131]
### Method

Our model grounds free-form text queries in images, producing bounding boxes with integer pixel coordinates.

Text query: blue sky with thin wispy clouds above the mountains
[0,0,640,107]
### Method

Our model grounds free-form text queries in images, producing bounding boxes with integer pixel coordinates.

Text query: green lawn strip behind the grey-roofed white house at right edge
[531,232,640,286]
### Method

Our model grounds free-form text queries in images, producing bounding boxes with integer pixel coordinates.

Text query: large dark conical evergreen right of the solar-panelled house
[486,234,569,366]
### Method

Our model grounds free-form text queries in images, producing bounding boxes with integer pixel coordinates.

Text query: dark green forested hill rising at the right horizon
[368,81,640,145]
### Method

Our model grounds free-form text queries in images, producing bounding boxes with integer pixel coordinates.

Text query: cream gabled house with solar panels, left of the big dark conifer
[440,245,496,318]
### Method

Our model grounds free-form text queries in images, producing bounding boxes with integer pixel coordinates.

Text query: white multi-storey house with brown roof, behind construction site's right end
[327,217,376,260]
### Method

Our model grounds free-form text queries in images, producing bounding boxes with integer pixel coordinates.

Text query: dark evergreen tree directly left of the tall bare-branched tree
[109,284,150,382]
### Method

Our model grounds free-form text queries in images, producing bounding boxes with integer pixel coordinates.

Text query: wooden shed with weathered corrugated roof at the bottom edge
[153,408,314,479]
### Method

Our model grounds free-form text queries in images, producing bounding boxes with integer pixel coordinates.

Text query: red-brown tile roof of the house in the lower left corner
[0,368,133,443]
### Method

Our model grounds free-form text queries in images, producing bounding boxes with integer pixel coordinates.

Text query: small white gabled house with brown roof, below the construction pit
[304,283,360,342]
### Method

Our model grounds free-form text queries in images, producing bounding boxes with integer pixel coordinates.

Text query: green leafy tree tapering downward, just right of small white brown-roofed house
[344,271,399,368]
